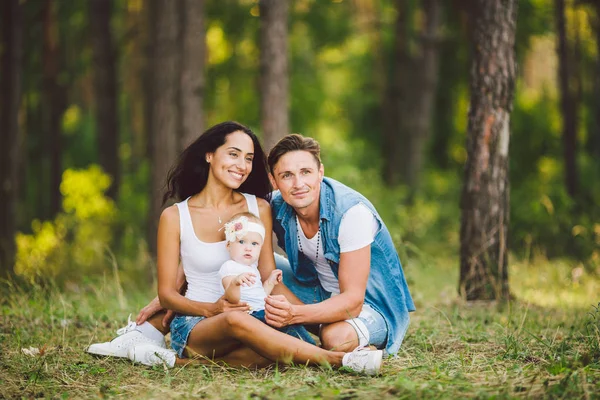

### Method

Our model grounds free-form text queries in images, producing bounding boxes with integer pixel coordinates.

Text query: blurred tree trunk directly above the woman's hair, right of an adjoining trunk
[179,0,206,150]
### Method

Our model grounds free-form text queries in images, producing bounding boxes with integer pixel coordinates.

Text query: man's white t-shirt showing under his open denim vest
[296,203,379,295]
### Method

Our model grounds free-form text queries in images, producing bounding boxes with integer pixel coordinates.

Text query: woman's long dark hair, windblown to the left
[163,121,273,205]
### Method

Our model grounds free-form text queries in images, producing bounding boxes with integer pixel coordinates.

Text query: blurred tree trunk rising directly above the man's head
[259,0,289,151]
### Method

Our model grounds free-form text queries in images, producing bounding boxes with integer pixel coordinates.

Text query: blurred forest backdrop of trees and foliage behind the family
[0,0,600,300]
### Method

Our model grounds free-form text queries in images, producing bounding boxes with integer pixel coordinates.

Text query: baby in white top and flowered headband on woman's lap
[219,213,315,344]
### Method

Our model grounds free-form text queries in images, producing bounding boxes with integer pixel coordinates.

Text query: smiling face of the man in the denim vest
[272,150,324,210]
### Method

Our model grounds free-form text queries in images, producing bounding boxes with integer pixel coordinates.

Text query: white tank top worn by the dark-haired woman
[177,193,260,303]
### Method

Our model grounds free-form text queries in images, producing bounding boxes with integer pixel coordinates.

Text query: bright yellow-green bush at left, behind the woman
[15,166,116,282]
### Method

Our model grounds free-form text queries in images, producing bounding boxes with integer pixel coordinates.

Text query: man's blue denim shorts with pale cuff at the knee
[275,254,388,349]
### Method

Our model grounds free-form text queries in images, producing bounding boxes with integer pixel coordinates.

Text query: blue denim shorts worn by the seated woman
[171,310,315,358]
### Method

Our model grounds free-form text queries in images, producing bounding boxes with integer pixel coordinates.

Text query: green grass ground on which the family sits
[0,259,600,399]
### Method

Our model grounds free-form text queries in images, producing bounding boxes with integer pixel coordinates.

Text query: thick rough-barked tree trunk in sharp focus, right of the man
[459,0,517,300]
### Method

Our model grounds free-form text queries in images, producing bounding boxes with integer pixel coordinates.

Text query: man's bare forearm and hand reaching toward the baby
[265,244,371,327]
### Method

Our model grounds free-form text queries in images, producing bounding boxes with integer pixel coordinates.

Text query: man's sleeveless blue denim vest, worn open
[271,178,415,354]
